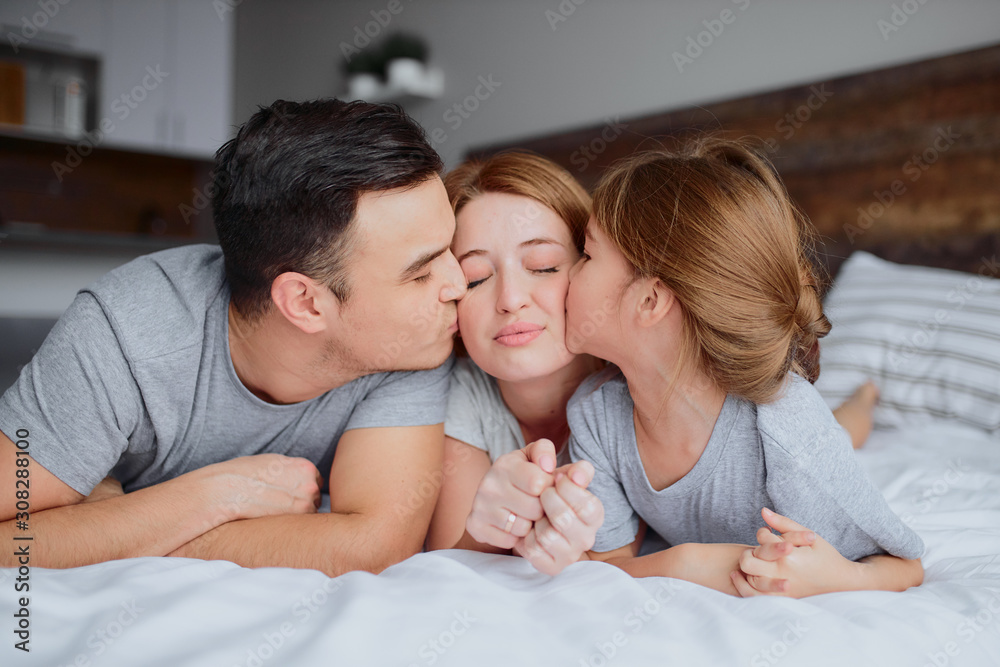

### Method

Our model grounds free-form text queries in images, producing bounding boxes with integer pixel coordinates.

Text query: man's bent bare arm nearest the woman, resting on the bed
[171,424,444,576]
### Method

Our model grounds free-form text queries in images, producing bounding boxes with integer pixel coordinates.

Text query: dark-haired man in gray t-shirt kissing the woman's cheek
[0,100,465,576]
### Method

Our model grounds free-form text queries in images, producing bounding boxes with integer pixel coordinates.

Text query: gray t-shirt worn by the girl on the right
[567,369,924,560]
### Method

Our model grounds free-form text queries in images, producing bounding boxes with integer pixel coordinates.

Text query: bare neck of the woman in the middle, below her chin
[497,354,600,451]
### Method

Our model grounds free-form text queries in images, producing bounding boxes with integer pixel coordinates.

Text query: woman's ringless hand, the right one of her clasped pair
[514,461,604,576]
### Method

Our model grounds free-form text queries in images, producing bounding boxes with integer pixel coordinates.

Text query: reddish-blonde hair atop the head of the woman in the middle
[444,151,591,252]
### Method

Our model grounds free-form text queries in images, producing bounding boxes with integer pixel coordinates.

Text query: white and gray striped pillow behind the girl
[816,252,1000,433]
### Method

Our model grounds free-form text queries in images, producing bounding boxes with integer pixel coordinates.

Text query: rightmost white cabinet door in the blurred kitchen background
[170,0,236,157]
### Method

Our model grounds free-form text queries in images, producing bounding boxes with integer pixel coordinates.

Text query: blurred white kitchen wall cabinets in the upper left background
[0,0,236,158]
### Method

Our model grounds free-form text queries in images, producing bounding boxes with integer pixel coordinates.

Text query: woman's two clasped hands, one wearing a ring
[465,439,604,575]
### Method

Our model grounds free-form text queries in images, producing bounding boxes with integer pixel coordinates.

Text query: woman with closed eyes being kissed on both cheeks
[427,153,874,588]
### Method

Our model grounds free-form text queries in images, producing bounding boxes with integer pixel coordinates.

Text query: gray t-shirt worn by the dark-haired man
[0,245,452,495]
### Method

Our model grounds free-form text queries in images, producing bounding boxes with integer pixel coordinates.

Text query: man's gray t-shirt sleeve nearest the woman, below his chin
[344,357,455,431]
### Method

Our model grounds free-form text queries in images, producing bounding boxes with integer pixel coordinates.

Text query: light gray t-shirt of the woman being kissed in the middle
[444,357,569,465]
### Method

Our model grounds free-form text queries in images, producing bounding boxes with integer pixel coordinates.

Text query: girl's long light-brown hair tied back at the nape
[594,136,830,403]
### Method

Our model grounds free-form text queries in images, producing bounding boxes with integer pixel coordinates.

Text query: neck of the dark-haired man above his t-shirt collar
[228,304,357,405]
